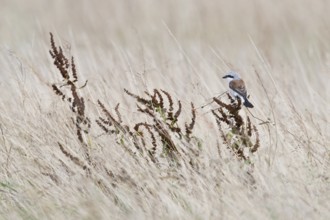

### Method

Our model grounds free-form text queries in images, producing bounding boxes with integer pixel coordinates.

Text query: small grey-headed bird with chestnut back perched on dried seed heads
[222,71,254,108]
